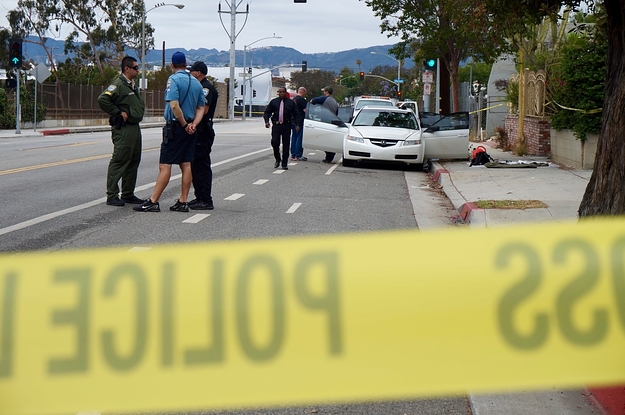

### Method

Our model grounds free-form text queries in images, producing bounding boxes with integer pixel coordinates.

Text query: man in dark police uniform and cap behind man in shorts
[189,61,219,210]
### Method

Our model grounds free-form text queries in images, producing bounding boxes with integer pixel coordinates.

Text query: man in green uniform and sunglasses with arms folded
[98,56,145,206]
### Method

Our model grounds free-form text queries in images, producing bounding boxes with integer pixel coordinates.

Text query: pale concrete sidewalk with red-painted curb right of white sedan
[430,142,616,415]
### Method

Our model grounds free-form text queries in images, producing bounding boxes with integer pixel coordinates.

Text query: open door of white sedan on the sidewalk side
[423,112,469,159]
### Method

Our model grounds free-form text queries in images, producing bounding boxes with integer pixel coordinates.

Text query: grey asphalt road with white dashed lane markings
[0,120,470,415]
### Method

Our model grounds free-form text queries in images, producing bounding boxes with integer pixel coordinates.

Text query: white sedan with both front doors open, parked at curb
[303,105,469,166]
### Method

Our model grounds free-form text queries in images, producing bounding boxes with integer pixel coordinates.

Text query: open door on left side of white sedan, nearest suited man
[302,103,346,154]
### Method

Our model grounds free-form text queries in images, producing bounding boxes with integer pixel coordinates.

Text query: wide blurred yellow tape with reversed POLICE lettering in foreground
[0,219,625,415]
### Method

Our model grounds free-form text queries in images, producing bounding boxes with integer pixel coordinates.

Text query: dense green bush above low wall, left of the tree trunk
[549,35,608,141]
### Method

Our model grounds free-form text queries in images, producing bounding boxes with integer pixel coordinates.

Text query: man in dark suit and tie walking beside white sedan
[263,87,304,170]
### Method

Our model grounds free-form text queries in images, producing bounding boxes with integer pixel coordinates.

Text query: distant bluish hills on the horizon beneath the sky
[24,39,414,73]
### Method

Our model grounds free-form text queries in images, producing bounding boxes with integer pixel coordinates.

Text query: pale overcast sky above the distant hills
[0,0,399,53]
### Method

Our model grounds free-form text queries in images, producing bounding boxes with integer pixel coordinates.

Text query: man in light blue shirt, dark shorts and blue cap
[134,52,204,212]
